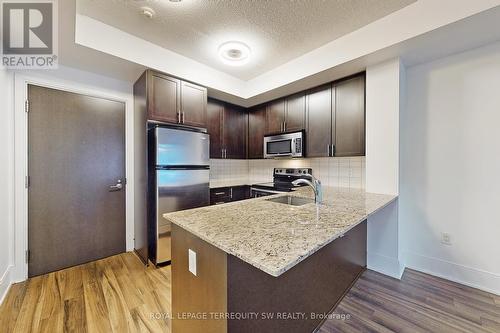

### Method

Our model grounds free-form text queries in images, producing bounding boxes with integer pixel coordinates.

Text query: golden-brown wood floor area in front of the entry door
[0,252,171,333]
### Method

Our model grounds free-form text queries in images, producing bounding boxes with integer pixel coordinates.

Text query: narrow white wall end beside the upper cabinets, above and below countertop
[366,59,404,278]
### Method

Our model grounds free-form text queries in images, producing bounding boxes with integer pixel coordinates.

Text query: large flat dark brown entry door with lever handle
[28,85,125,277]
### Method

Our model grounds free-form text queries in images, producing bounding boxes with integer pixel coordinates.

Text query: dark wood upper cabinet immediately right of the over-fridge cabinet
[207,99,248,159]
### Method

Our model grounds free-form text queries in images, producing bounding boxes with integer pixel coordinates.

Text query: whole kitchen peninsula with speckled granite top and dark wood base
[164,187,396,332]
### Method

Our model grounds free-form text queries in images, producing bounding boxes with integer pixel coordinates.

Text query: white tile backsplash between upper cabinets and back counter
[210,157,365,189]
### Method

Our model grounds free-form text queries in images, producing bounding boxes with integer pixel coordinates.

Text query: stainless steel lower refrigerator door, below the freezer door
[156,169,210,264]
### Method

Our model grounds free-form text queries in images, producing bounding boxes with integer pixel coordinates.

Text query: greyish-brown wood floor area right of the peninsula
[318,269,500,333]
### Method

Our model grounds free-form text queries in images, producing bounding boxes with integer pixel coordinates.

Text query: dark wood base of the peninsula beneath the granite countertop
[172,221,367,333]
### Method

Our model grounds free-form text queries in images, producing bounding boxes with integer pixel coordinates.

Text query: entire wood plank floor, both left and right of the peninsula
[0,253,500,333]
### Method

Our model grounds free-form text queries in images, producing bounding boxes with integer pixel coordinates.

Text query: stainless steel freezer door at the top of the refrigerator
[156,127,210,166]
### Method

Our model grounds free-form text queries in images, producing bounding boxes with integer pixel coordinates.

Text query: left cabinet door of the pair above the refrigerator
[148,71,181,124]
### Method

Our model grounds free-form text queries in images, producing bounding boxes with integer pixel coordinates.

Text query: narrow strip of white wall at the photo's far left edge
[0,68,14,303]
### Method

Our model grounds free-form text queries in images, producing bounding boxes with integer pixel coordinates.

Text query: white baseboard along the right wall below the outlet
[404,251,500,296]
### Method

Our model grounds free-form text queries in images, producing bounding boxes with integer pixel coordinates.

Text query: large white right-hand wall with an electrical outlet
[400,43,500,294]
